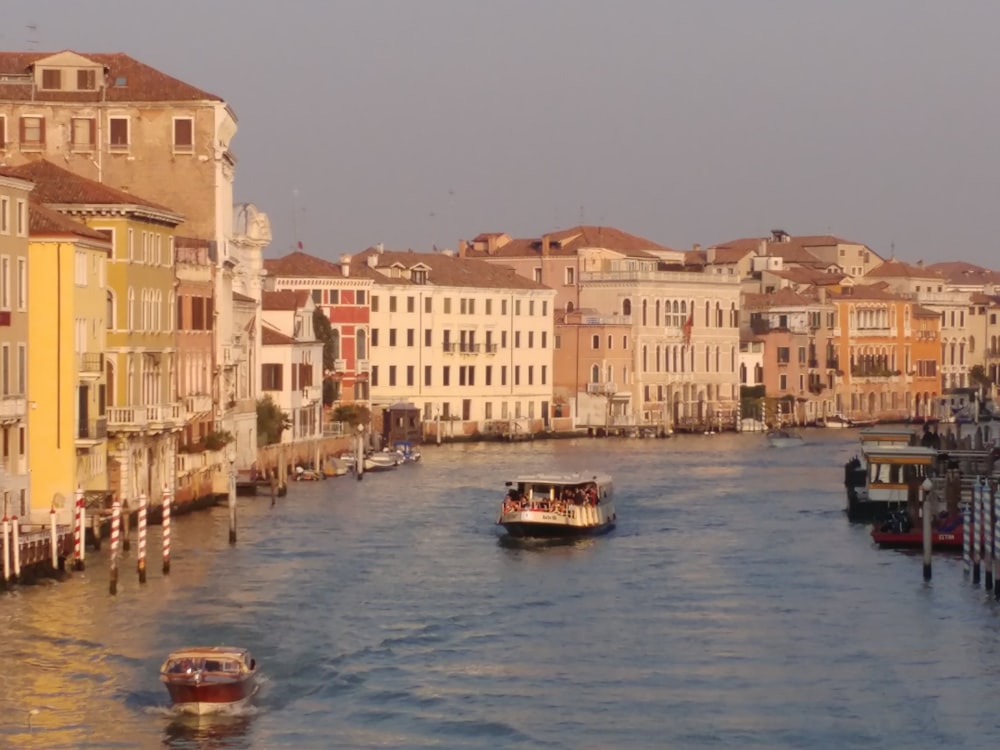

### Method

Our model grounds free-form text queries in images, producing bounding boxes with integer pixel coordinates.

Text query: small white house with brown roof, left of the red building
[260,289,323,443]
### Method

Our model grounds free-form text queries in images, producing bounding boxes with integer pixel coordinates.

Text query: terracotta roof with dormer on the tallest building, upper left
[0,50,223,102]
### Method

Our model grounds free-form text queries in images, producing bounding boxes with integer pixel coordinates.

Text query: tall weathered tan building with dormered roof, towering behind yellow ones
[0,50,259,468]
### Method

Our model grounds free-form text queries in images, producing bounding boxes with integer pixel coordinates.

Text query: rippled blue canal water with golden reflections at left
[0,430,1000,750]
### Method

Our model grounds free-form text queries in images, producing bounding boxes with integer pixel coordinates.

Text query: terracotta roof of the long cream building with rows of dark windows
[351,248,548,289]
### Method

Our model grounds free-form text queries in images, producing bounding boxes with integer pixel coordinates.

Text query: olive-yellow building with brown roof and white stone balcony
[9,160,186,507]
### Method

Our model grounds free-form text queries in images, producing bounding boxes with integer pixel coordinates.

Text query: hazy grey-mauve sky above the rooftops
[0,0,1000,268]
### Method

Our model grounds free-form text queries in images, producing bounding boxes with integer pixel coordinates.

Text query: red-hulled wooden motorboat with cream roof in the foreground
[160,646,258,715]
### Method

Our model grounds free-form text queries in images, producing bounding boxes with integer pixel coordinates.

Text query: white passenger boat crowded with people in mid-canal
[497,474,617,537]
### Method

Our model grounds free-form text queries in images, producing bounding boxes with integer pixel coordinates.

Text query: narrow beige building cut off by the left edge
[0,169,32,518]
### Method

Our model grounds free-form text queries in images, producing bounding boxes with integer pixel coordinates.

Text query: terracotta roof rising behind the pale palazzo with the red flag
[465,225,678,258]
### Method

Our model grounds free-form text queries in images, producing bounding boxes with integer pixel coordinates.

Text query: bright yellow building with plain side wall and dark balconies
[28,203,111,523]
